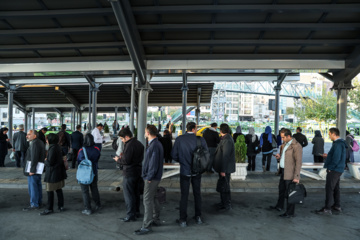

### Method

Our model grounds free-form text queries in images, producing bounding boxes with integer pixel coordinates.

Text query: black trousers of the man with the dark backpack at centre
[180,174,201,221]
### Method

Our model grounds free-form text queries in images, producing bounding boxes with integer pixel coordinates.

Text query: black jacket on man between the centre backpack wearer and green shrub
[213,134,235,173]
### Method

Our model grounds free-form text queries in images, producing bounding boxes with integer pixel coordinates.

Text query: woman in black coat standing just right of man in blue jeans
[40,133,66,216]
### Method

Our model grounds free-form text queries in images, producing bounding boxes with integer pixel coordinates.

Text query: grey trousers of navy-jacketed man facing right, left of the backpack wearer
[142,180,160,228]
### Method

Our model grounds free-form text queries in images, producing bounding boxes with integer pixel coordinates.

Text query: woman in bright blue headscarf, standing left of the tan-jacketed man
[260,126,276,172]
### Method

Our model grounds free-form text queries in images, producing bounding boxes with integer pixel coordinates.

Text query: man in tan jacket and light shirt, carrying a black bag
[270,128,302,218]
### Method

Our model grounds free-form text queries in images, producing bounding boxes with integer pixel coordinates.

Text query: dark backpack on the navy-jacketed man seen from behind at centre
[191,137,211,174]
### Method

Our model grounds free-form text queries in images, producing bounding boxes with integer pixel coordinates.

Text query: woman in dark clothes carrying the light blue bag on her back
[78,133,101,215]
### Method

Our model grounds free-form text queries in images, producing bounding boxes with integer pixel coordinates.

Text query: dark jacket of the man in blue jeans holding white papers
[24,138,45,176]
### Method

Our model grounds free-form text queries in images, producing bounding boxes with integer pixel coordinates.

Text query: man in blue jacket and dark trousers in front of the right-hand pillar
[316,128,348,215]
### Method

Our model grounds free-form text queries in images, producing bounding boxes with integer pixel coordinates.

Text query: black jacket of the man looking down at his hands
[118,138,144,177]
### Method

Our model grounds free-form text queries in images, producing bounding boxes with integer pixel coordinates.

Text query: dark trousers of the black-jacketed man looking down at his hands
[123,176,142,218]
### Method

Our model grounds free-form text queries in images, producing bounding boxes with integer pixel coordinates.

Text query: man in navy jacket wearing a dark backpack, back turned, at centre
[171,122,208,227]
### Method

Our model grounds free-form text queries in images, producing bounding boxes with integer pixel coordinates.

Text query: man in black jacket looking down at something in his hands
[114,128,144,222]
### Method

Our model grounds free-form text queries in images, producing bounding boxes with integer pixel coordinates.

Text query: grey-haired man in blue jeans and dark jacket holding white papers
[23,130,45,211]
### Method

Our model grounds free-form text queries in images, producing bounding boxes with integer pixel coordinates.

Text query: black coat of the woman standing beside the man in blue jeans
[44,144,66,183]
